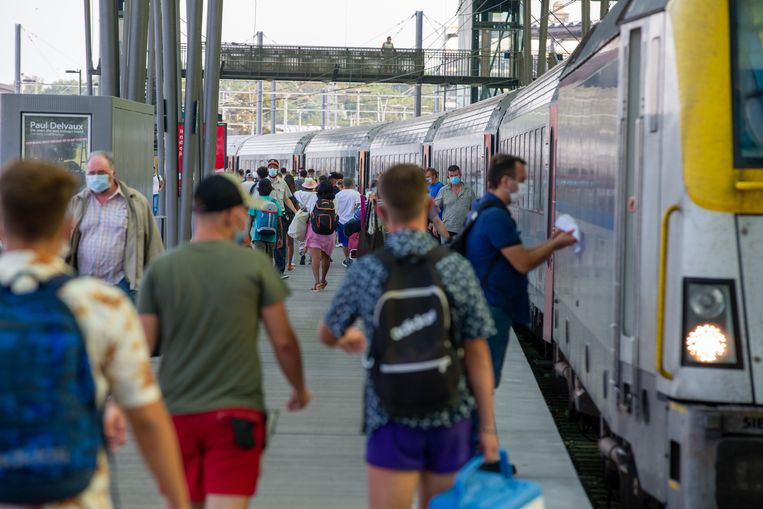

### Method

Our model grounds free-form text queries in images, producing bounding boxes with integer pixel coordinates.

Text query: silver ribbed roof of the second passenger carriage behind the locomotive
[434,93,515,140]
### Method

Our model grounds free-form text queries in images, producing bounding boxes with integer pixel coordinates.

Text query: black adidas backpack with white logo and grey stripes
[365,247,463,417]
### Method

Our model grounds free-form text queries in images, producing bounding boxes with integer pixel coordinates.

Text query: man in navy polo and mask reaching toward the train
[466,154,576,387]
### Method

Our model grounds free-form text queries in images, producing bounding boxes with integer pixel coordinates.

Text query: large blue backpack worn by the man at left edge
[0,276,103,505]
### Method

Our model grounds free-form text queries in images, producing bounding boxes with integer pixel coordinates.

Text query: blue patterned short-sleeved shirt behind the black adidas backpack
[324,230,496,434]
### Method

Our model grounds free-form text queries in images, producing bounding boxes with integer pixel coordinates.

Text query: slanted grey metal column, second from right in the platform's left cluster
[178,0,203,242]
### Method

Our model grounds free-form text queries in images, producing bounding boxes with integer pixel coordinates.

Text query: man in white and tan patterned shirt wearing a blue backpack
[0,161,190,509]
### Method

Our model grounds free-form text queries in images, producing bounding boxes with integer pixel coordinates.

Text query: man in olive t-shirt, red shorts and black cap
[138,174,311,508]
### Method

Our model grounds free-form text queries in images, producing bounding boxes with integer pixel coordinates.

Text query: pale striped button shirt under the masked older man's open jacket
[77,189,128,285]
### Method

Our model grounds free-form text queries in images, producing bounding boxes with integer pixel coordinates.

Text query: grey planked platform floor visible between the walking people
[116,260,590,509]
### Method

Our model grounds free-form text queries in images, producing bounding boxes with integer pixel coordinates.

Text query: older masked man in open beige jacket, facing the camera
[67,151,164,300]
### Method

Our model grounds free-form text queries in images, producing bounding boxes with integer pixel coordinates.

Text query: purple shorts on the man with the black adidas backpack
[366,419,472,474]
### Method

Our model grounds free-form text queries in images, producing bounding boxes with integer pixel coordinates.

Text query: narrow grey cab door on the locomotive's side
[615,26,644,414]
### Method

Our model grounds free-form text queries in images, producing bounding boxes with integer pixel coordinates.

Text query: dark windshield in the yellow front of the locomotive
[731,0,763,168]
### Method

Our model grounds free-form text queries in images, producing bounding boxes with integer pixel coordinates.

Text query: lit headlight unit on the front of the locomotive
[682,279,742,368]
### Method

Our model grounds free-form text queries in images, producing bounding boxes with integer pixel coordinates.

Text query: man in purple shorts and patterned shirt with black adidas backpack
[320,165,498,509]
